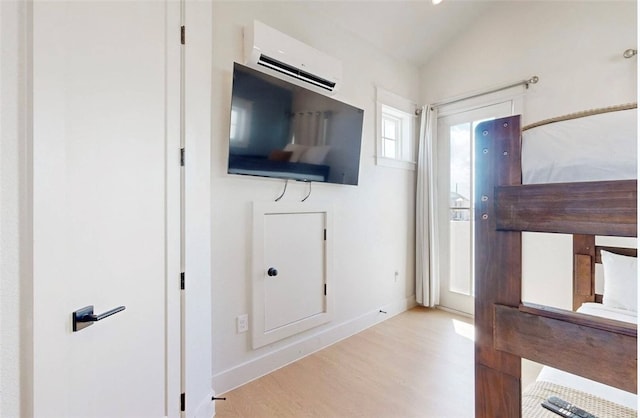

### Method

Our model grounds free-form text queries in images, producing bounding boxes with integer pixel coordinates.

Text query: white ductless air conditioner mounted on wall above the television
[244,20,342,94]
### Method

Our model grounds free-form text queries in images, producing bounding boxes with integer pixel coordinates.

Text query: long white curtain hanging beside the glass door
[416,106,440,307]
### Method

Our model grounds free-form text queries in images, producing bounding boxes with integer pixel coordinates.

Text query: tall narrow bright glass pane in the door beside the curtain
[449,123,473,295]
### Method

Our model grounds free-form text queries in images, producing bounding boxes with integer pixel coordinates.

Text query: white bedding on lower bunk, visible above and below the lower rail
[536,303,638,410]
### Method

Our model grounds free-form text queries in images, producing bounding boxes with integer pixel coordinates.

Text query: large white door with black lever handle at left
[32,1,180,417]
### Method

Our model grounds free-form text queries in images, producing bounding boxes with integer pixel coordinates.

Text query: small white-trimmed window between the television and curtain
[376,88,417,170]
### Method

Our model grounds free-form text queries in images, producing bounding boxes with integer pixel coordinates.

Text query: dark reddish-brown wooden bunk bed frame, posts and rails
[475,116,637,418]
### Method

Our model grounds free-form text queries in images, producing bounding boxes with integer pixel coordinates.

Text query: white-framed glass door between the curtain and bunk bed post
[437,100,513,315]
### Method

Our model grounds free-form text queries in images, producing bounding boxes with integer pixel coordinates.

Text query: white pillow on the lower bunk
[600,251,638,312]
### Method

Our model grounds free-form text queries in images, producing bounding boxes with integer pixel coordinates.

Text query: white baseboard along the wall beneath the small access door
[212,295,416,394]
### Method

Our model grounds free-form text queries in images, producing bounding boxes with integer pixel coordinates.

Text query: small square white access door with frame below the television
[252,203,331,348]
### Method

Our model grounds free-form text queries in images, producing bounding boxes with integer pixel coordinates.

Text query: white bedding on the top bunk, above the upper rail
[522,109,638,184]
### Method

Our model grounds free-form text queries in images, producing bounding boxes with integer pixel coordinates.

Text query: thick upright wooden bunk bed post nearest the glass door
[474,116,522,418]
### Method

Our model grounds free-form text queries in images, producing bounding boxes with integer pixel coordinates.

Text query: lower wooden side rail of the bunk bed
[494,305,638,393]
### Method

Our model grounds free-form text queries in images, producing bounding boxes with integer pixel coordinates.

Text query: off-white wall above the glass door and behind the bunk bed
[421,1,637,308]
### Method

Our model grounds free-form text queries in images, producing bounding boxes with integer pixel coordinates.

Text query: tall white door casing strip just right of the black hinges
[182,0,215,418]
